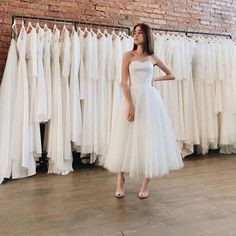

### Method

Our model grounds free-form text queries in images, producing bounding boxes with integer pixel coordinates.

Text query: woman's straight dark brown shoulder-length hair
[133,23,154,55]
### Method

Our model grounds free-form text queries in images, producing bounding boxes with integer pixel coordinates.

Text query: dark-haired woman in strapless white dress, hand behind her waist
[104,24,183,199]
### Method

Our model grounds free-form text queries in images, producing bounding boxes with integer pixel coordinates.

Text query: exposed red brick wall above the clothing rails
[0,0,236,80]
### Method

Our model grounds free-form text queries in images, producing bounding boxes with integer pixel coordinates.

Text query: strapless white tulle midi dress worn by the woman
[104,61,183,178]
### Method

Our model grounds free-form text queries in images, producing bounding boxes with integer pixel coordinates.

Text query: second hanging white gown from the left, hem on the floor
[10,26,36,179]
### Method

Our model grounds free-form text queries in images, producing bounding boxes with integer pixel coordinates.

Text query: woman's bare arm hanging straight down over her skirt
[121,52,134,121]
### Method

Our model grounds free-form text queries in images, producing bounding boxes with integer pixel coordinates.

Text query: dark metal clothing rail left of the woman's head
[12,15,131,35]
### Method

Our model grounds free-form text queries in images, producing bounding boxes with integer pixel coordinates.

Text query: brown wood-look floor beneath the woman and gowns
[0,155,236,236]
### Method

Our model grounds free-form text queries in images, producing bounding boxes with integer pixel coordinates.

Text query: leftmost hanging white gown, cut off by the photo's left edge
[0,39,18,184]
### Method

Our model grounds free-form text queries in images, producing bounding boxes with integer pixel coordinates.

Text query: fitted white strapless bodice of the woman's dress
[129,60,153,86]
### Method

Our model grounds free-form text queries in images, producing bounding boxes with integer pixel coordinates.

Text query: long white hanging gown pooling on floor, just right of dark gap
[48,28,73,175]
